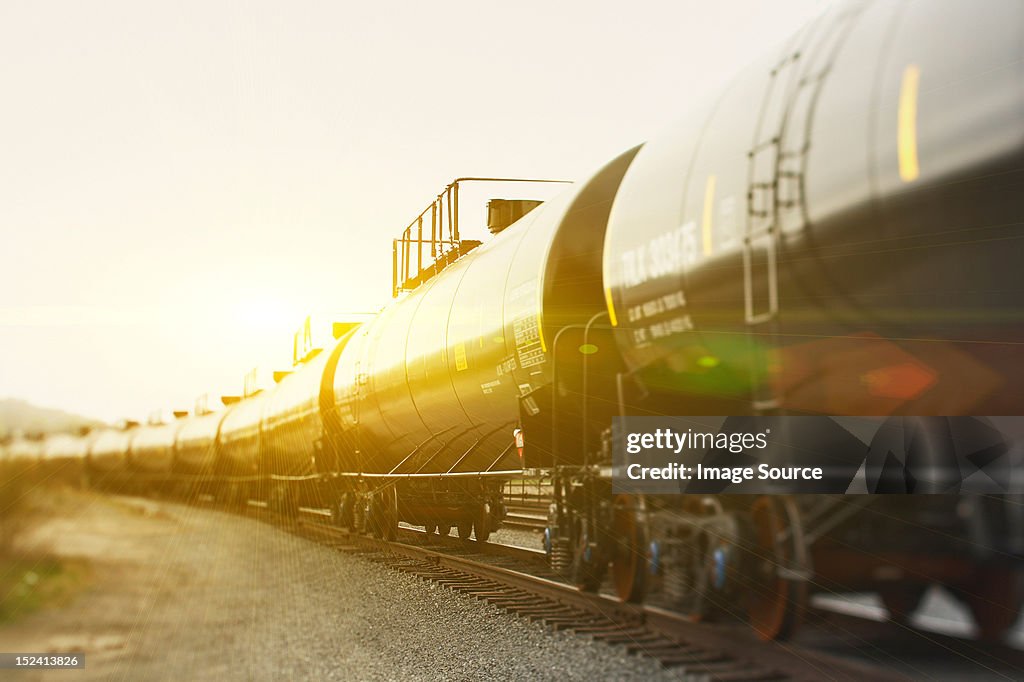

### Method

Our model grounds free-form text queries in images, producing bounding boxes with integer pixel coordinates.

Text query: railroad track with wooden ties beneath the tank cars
[186,493,1024,682]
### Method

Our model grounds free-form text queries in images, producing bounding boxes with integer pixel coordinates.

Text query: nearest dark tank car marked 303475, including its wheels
[581,2,1024,638]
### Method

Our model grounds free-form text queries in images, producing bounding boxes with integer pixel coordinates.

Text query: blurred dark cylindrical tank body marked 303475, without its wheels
[604,2,1024,416]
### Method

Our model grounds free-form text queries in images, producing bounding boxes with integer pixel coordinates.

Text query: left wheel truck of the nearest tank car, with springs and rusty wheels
[548,495,819,640]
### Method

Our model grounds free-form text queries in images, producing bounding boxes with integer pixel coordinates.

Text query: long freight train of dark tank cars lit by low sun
[2,1,1024,639]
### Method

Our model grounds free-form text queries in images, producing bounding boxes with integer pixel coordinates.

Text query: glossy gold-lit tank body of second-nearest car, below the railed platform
[334,150,635,475]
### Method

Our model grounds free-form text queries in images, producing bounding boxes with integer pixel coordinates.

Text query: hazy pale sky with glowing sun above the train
[0,0,824,420]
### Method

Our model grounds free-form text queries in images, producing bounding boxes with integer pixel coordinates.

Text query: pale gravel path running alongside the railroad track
[0,494,677,682]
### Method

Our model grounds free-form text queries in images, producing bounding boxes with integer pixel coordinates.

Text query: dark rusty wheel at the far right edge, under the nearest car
[953,566,1024,642]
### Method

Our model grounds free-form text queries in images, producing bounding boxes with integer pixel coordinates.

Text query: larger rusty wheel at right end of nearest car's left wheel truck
[748,496,807,641]
